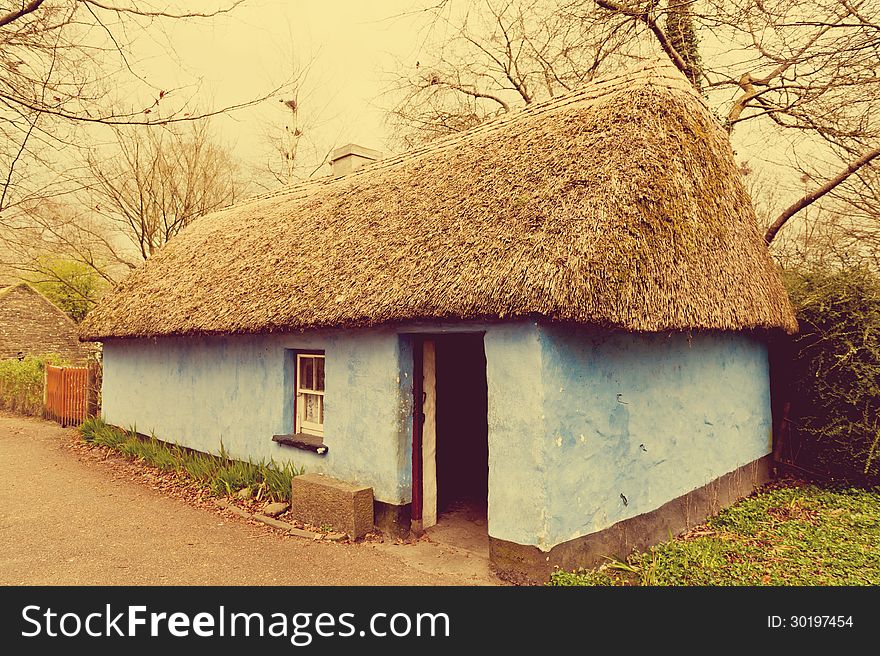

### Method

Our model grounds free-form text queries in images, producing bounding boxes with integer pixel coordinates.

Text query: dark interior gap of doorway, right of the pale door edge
[435,333,489,526]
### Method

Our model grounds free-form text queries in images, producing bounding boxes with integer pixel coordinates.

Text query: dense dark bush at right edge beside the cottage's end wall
[786,266,880,484]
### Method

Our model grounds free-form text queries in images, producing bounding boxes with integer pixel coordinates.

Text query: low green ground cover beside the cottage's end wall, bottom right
[550,485,880,586]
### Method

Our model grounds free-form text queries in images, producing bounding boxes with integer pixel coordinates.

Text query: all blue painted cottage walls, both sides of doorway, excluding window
[103,322,771,549]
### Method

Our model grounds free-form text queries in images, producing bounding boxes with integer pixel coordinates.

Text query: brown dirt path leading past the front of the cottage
[0,414,500,585]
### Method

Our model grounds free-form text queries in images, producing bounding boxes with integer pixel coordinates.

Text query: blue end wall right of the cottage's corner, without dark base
[502,324,771,549]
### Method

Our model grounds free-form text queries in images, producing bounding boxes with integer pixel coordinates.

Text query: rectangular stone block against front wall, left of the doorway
[290,474,373,539]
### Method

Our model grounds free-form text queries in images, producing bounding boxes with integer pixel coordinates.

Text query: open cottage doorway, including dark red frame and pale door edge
[413,333,489,551]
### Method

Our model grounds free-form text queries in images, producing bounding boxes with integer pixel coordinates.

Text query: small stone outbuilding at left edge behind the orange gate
[0,282,94,364]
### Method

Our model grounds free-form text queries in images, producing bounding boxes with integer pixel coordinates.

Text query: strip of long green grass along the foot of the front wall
[80,418,303,501]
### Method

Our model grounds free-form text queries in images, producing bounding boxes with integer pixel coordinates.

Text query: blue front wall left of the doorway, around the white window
[103,331,412,503]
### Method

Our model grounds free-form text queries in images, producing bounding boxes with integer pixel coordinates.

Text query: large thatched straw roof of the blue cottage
[81,60,797,339]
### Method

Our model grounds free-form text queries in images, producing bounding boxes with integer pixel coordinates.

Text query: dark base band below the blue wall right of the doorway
[489,455,773,584]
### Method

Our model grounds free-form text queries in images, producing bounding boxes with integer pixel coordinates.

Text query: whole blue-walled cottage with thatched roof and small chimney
[83,65,796,577]
